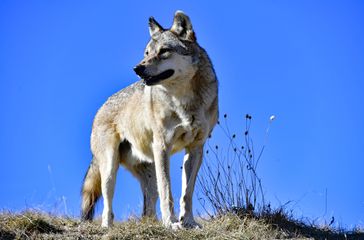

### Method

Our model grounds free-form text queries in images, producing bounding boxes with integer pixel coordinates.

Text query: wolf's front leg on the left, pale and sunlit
[153,141,177,228]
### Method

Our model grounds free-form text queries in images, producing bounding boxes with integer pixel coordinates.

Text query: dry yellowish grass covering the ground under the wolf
[0,211,364,239]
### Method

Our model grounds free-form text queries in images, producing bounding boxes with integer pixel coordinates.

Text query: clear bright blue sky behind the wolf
[0,0,364,227]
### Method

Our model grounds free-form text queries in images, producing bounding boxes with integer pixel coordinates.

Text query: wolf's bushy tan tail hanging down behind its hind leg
[81,158,101,221]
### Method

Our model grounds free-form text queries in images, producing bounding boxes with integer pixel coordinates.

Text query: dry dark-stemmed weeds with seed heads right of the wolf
[197,114,364,240]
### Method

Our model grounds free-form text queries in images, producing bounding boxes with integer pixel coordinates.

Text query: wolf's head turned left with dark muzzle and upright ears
[134,11,199,86]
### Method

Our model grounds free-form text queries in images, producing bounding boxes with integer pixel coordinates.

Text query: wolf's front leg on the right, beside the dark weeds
[178,146,203,228]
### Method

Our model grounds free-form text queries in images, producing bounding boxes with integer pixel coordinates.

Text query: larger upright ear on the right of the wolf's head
[171,11,196,42]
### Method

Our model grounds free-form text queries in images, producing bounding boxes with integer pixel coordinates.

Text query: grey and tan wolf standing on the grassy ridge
[81,11,218,229]
